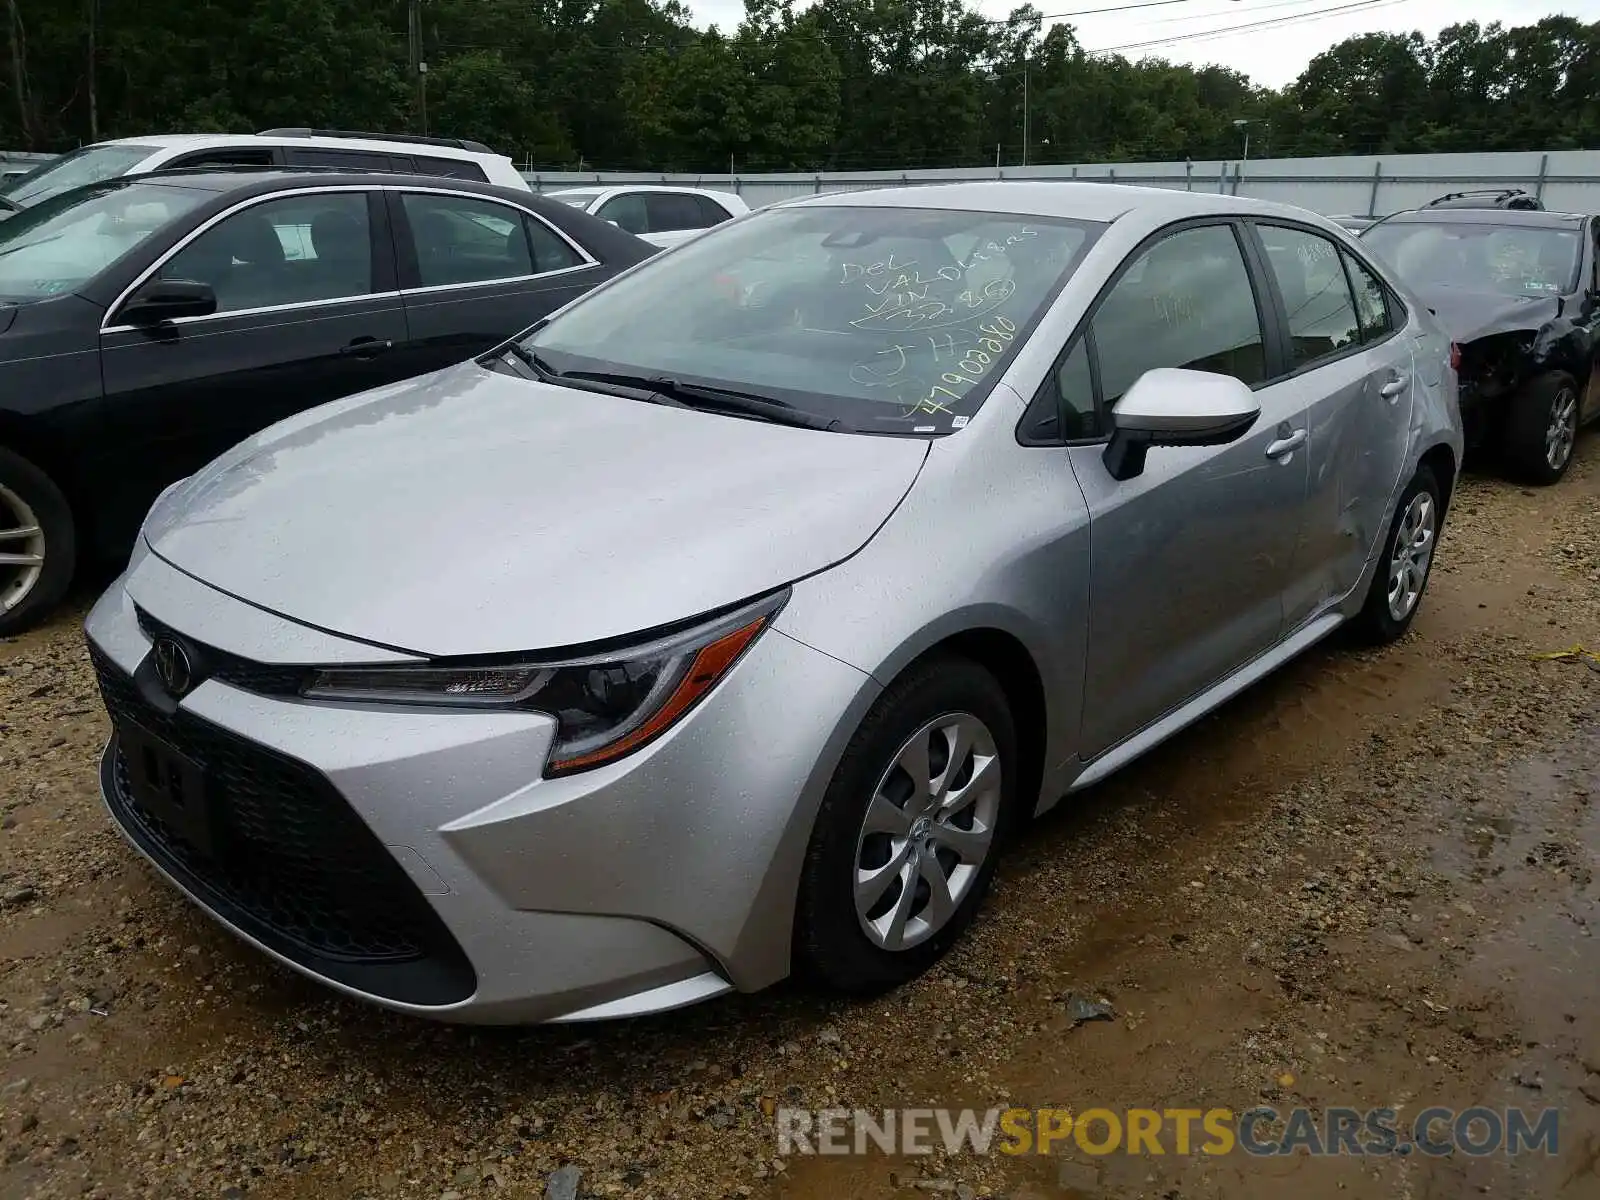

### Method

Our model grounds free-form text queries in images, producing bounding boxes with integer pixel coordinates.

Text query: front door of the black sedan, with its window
[101,189,406,531]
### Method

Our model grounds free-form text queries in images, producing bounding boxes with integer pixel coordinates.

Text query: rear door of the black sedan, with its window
[387,189,608,374]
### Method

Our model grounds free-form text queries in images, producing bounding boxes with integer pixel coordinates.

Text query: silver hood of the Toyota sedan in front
[144,363,928,656]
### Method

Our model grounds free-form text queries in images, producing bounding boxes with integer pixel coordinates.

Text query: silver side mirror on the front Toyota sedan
[1104,366,1261,480]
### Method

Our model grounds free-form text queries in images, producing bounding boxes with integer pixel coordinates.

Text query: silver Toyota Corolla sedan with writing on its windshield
[88,182,1461,1022]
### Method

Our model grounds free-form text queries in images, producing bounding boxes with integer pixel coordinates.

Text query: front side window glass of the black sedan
[160,192,373,312]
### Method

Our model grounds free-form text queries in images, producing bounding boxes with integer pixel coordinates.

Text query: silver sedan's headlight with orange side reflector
[302,589,789,776]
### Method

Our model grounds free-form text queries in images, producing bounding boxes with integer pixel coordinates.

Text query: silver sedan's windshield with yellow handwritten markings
[523,205,1104,434]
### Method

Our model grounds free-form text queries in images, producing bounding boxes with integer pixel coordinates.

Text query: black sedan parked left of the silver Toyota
[0,171,658,634]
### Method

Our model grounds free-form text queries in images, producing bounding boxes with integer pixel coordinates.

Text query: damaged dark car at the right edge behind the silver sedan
[1360,205,1600,485]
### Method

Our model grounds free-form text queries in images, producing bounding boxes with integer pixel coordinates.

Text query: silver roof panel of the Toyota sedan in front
[778,179,1326,222]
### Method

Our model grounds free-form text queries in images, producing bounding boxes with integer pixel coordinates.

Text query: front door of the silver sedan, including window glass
[1069,224,1307,758]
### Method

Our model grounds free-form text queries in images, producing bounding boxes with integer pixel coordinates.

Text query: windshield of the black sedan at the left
[0,182,213,301]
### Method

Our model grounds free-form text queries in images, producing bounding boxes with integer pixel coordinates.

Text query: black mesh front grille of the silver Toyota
[90,645,475,1005]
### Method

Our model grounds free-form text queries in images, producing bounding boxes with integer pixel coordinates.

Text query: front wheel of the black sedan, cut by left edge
[0,446,77,637]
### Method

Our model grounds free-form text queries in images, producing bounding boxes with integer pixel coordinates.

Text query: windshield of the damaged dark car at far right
[1362,221,1581,296]
